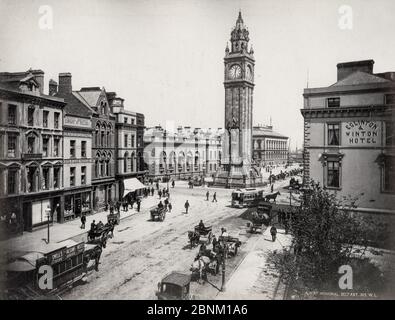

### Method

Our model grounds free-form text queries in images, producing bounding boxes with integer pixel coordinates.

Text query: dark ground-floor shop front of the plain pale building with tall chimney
[63,187,92,221]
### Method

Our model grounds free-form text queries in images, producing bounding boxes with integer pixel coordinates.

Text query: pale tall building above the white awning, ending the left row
[107,92,147,199]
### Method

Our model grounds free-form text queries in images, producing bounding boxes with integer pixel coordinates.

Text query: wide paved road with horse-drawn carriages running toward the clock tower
[63,181,294,299]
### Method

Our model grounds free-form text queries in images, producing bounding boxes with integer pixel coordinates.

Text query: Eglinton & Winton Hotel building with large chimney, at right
[301,60,395,212]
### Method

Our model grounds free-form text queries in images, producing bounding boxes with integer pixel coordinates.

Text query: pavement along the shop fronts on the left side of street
[0,194,159,254]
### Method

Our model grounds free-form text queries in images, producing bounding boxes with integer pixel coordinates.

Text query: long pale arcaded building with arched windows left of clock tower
[144,126,223,179]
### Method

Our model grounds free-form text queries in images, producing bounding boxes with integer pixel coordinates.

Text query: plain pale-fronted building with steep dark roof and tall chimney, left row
[54,73,93,222]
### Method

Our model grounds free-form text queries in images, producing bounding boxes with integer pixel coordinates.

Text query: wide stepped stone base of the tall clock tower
[213,166,263,189]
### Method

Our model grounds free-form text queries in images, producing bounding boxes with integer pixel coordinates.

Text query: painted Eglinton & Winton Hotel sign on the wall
[342,120,381,146]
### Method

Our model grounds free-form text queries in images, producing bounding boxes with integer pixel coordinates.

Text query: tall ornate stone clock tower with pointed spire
[214,12,262,188]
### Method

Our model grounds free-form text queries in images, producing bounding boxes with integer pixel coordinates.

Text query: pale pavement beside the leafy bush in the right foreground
[216,227,291,300]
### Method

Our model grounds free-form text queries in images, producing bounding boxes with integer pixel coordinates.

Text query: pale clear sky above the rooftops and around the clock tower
[0,0,395,149]
